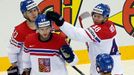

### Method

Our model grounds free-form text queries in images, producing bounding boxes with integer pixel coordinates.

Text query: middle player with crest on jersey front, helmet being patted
[22,14,77,75]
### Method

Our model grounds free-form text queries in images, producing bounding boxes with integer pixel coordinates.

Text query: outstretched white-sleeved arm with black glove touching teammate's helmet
[46,12,100,42]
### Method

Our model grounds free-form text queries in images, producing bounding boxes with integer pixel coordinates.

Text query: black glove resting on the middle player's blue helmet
[46,11,65,26]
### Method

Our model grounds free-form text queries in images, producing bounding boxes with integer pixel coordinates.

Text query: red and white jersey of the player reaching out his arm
[60,21,122,75]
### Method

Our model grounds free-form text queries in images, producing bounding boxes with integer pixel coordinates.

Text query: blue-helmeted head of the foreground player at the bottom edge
[96,53,114,75]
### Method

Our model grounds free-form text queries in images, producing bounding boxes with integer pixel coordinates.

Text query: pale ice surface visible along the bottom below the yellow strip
[0,60,134,75]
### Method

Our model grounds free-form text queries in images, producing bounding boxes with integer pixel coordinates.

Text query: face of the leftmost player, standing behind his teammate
[26,8,39,22]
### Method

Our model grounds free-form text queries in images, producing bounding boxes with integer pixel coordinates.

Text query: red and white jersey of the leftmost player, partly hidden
[8,21,35,73]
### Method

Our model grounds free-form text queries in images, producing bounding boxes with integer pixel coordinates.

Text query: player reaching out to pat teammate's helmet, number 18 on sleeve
[46,3,123,75]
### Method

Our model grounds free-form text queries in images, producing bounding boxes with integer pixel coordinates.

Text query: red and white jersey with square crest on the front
[22,33,76,75]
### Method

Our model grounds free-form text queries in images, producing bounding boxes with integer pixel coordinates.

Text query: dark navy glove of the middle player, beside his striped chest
[60,45,75,63]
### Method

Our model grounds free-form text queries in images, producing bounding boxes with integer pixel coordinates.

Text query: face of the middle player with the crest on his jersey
[38,26,52,40]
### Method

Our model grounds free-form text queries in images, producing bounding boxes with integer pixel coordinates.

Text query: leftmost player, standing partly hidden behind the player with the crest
[8,0,39,75]
